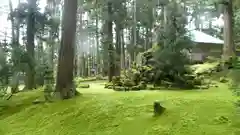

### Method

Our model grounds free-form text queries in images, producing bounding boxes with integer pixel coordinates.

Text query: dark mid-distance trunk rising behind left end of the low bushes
[107,2,115,82]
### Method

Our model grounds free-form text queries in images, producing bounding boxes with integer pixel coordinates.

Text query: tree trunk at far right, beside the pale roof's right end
[223,0,235,60]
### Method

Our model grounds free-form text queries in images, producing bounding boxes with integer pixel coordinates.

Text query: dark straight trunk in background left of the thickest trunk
[26,0,37,90]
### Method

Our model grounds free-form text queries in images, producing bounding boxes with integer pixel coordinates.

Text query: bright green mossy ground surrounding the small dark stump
[0,84,240,135]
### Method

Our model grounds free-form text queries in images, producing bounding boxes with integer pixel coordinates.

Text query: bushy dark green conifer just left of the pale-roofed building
[154,2,193,87]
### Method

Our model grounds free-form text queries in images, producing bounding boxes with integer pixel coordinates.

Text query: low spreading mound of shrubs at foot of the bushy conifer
[105,62,204,91]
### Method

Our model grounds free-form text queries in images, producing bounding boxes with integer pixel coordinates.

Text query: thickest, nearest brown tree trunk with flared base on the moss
[55,0,77,99]
